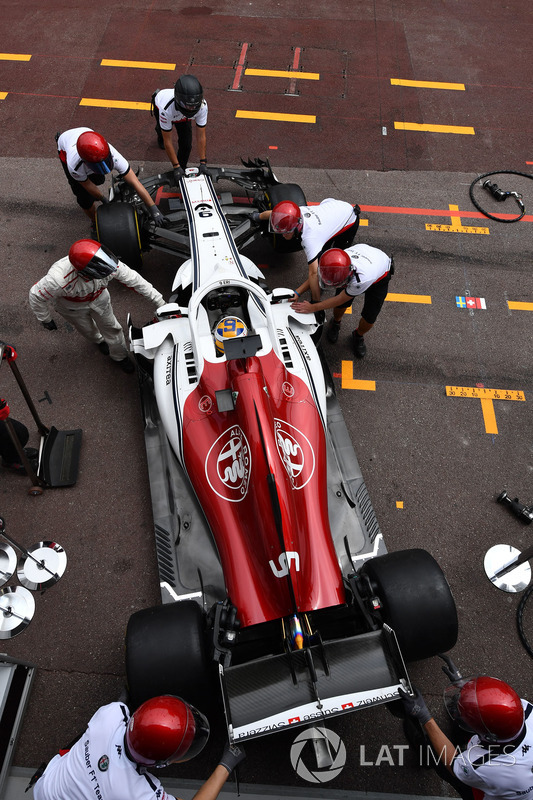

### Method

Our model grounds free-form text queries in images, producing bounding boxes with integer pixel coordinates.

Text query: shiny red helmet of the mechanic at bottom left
[126,694,209,767]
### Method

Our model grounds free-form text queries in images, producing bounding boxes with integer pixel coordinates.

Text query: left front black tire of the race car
[96,203,143,270]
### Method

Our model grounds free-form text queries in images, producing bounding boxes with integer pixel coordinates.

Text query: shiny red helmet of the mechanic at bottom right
[444,675,524,743]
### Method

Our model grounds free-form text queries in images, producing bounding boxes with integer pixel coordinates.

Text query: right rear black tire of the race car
[361,549,458,661]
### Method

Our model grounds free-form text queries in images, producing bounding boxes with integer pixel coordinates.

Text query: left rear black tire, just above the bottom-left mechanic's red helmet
[126,600,214,713]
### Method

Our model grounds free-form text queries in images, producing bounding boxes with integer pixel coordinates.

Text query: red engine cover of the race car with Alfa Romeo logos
[183,352,345,626]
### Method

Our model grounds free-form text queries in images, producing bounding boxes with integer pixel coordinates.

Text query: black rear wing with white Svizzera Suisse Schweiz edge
[219,625,410,741]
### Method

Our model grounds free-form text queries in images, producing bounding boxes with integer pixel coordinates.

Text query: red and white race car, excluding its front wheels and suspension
[126,167,457,741]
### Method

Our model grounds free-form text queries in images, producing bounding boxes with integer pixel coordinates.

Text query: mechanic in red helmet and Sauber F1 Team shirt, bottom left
[33,695,245,800]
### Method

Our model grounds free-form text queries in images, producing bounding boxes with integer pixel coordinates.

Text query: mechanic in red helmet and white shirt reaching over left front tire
[56,128,165,226]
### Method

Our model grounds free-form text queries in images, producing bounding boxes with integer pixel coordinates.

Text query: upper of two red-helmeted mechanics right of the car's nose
[252,197,361,302]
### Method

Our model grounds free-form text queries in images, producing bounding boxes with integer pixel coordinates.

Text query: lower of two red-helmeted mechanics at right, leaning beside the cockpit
[291,244,394,358]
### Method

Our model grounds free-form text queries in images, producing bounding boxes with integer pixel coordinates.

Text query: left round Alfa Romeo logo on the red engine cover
[205,425,251,503]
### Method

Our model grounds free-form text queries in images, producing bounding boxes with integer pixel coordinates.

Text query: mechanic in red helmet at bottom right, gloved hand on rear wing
[401,675,533,800]
